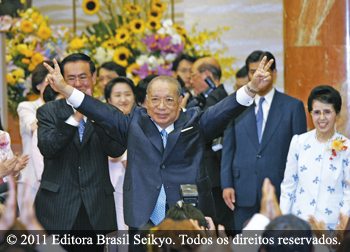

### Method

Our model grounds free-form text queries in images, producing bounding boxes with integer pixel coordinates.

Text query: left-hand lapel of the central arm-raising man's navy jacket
[138,113,164,153]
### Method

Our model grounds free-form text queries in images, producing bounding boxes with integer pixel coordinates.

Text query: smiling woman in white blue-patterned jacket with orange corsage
[280,86,350,230]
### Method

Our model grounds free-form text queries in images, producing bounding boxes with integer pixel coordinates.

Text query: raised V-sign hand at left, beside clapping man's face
[44,59,74,98]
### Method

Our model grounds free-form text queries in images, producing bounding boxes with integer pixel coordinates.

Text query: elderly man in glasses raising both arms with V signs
[43,56,272,228]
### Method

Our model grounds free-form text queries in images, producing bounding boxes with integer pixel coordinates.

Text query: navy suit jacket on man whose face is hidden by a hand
[221,90,306,207]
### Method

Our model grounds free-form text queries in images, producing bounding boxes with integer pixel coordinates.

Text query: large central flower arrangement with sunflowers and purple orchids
[76,0,235,93]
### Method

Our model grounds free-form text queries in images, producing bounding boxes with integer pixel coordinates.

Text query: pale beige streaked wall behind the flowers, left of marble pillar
[33,0,284,91]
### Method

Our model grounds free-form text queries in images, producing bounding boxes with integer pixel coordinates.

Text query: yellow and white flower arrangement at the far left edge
[0,8,70,117]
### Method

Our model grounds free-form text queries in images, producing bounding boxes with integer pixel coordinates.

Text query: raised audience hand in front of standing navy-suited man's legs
[260,178,282,220]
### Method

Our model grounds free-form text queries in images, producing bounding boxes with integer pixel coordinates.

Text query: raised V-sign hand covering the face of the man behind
[249,56,273,91]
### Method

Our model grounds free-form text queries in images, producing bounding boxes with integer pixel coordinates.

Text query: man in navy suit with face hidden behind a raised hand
[221,51,306,232]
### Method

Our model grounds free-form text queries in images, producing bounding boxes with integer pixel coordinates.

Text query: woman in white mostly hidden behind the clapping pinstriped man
[17,61,53,210]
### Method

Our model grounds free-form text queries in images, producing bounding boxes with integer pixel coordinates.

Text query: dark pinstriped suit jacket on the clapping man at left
[35,99,125,231]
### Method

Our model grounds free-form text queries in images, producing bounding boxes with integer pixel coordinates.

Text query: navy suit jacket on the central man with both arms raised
[77,91,247,228]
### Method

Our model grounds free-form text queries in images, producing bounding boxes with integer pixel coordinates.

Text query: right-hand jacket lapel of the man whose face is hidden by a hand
[260,90,283,151]
